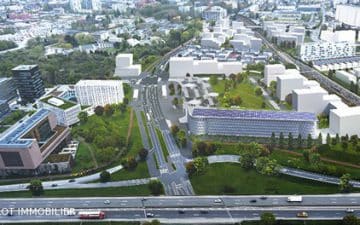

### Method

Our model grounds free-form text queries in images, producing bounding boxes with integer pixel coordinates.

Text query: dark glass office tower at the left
[12,65,45,103]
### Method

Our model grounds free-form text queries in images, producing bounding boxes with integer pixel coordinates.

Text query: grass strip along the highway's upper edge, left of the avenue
[0,185,150,198]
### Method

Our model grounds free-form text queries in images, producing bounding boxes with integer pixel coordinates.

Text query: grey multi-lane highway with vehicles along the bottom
[0,194,360,223]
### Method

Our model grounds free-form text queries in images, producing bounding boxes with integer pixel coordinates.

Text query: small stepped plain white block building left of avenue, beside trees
[114,54,141,77]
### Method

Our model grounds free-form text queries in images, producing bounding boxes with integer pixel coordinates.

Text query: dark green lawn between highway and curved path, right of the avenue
[190,163,339,195]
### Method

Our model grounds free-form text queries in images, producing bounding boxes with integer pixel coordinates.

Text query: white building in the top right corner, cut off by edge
[335,5,360,27]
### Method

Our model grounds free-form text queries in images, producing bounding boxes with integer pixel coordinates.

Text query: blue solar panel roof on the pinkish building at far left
[0,109,50,146]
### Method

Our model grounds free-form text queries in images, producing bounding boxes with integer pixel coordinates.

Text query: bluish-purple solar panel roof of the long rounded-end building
[192,108,316,122]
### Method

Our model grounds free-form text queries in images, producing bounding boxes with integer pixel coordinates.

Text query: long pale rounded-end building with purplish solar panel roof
[188,108,316,137]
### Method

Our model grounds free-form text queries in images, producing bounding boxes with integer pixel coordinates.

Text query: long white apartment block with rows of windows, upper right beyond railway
[300,41,356,61]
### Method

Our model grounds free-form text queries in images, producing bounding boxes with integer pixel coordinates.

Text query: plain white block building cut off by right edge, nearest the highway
[329,106,360,136]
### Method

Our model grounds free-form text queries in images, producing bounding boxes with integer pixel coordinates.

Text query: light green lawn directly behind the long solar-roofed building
[212,80,269,109]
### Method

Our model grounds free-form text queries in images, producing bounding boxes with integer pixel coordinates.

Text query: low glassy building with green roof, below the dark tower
[38,96,81,126]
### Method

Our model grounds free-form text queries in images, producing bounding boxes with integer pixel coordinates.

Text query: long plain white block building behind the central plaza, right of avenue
[169,57,242,78]
